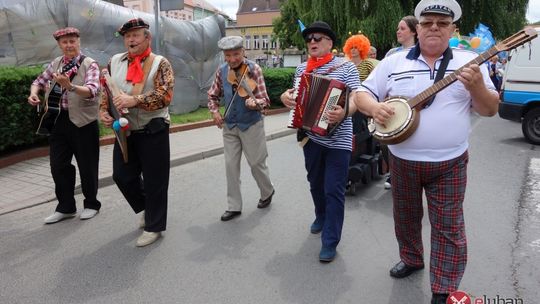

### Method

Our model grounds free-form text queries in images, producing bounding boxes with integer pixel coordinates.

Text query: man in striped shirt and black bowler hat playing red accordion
[281,21,360,262]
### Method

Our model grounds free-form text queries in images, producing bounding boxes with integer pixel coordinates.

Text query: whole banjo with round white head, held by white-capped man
[369,28,538,145]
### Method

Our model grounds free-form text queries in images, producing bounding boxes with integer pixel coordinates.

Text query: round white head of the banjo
[374,97,413,138]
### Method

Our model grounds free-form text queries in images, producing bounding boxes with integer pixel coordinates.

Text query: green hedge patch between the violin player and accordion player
[263,68,295,108]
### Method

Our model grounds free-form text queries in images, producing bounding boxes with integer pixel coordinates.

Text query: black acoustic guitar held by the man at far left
[36,58,78,136]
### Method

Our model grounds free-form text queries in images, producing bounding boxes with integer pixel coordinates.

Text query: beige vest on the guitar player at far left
[46,56,100,128]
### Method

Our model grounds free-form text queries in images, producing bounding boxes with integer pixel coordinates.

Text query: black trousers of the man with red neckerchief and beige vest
[113,128,171,232]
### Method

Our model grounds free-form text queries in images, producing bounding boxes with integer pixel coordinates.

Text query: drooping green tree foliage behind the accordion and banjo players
[273,0,529,54]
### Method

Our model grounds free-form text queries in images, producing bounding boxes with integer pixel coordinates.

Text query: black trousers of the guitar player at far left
[49,111,101,213]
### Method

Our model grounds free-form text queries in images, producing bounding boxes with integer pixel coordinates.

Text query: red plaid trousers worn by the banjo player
[390,151,469,293]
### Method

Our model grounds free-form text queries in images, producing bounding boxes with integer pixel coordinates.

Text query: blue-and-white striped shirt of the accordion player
[295,57,360,151]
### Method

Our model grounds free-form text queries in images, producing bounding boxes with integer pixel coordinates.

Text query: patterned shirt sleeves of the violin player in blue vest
[208,59,270,113]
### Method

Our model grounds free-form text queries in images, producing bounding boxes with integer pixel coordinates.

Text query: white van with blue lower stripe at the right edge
[499,27,540,145]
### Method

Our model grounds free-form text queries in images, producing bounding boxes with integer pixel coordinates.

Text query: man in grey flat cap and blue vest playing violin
[208,36,275,221]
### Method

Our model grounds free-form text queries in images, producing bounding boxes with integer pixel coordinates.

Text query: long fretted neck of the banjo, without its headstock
[408,47,499,108]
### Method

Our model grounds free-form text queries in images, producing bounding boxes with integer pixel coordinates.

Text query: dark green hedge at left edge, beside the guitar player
[0,67,47,154]
